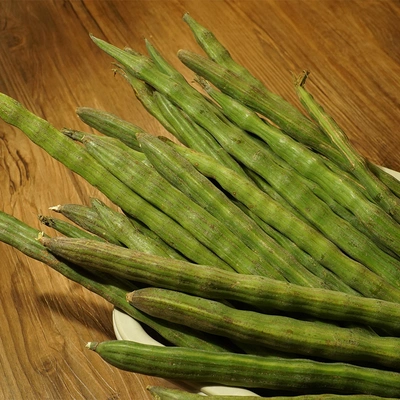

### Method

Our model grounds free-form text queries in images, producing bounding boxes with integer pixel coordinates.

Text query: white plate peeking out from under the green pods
[113,167,400,397]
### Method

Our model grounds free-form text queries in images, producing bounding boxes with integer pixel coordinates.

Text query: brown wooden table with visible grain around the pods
[0,0,400,400]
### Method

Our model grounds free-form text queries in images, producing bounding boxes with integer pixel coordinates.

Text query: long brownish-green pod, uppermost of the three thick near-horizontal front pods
[40,237,400,334]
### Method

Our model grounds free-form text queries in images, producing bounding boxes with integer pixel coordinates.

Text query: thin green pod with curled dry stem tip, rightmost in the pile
[296,74,400,222]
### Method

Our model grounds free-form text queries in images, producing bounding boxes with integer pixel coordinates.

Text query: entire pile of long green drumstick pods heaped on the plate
[0,15,400,399]
